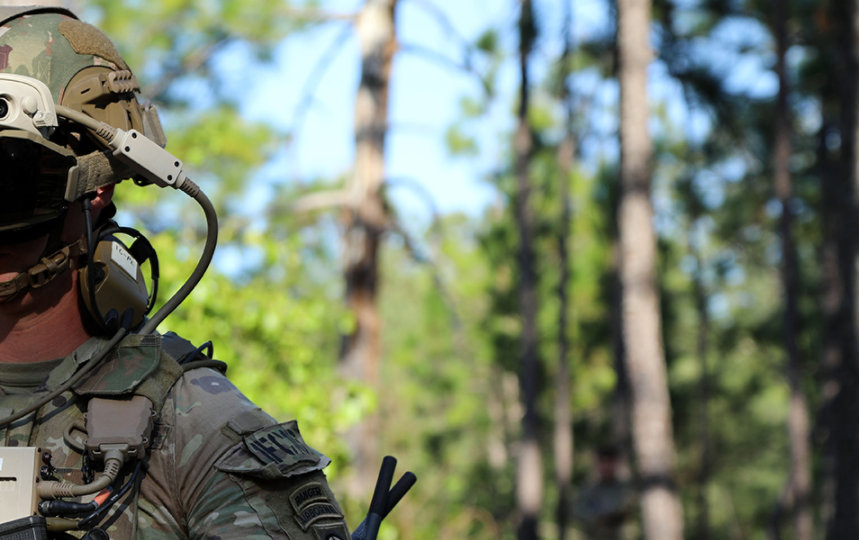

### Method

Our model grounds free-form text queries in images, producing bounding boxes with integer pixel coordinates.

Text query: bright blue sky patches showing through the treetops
[208,0,620,224]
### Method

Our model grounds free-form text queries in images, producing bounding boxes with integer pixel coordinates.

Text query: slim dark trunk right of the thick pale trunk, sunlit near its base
[773,2,813,540]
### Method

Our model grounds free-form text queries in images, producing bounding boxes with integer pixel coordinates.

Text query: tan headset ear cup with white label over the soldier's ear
[79,225,158,332]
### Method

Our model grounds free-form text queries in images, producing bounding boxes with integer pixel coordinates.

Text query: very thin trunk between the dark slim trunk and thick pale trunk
[554,3,575,540]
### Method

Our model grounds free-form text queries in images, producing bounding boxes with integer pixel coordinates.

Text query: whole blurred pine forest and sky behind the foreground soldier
[25,0,859,540]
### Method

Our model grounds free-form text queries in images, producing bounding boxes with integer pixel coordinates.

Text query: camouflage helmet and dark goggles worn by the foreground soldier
[0,7,166,242]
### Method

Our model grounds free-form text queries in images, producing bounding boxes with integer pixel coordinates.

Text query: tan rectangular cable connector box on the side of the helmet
[110,129,185,189]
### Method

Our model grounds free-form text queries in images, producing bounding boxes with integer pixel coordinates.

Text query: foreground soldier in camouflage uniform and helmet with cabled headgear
[0,7,349,540]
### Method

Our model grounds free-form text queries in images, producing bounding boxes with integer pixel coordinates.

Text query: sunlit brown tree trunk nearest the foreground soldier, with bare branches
[340,0,397,496]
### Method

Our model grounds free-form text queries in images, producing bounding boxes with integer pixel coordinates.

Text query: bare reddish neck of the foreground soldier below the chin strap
[0,272,90,364]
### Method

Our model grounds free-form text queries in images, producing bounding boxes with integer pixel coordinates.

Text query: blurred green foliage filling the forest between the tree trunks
[82,0,852,540]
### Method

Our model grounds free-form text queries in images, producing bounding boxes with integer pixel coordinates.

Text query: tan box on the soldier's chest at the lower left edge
[0,447,40,524]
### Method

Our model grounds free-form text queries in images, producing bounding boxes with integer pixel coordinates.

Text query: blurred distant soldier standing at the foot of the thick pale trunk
[573,445,635,540]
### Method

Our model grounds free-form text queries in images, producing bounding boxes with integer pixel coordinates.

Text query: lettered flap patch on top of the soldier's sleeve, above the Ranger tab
[215,420,331,480]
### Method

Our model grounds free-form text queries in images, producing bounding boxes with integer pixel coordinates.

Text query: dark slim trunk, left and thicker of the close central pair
[514,0,543,540]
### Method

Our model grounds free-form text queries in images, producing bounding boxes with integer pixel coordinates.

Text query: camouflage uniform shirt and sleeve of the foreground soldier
[0,338,349,540]
